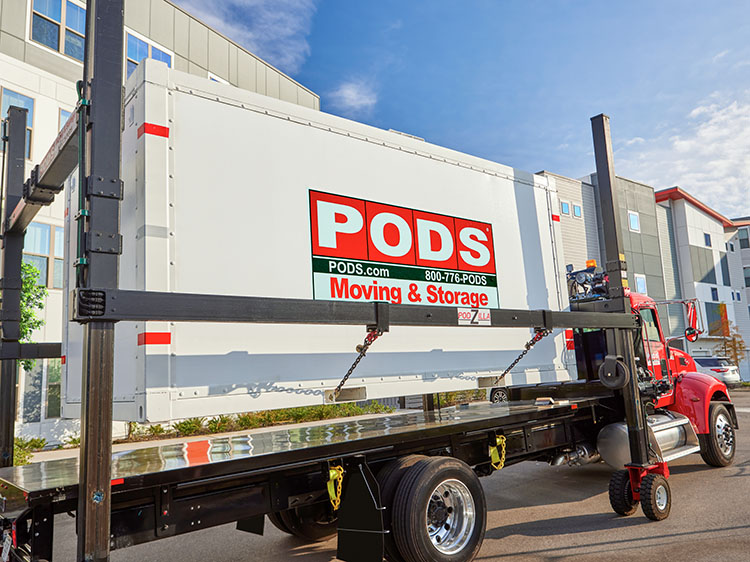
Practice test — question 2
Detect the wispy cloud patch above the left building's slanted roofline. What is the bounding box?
[175,0,316,74]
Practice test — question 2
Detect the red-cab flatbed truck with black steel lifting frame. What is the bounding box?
[0,0,737,562]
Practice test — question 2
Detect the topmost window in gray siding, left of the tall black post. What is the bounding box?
[31,0,86,62]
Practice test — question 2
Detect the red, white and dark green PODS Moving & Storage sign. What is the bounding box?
[310,191,497,306]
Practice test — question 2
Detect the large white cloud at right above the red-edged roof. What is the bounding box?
[616,91,750,218]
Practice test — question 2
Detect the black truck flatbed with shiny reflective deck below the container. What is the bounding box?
[0,388,619,560]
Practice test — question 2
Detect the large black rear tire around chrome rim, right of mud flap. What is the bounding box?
[393,457,487,562]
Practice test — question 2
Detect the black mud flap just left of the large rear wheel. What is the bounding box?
[336,457,385,562]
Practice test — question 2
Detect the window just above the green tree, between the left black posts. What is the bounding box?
[23,222,65,289]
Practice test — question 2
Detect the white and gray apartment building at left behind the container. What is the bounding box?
[0,0,320,443]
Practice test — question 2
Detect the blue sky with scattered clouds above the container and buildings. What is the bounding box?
[178,0,750,217]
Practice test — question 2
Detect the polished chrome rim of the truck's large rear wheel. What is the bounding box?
[425,479,476,555]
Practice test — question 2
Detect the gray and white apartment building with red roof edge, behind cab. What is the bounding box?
[541,168,750,380]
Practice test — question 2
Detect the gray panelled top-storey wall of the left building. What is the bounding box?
[0,0,320,109]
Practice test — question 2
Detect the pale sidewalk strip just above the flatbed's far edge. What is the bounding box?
[31,410,419,463]
